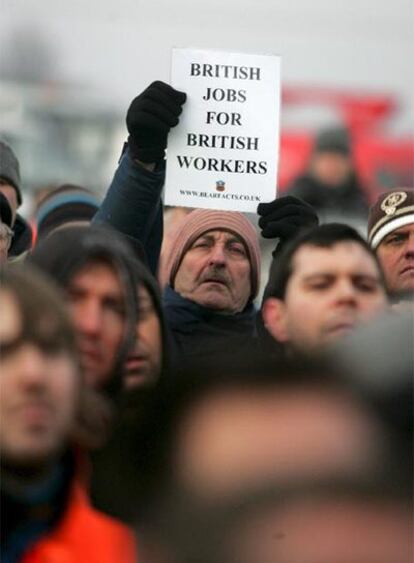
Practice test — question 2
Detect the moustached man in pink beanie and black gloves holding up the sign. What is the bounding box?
[94,53,317,368]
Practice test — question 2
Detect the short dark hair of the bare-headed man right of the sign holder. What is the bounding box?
[265,223,385,299]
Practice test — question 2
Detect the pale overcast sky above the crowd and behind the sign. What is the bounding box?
[0,0,414,121]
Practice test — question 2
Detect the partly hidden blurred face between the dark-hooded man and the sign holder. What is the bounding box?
[124,286,162,389]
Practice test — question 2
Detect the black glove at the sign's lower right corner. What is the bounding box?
[257,195,319,244]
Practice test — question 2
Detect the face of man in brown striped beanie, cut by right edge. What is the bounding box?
[377,224,414,293]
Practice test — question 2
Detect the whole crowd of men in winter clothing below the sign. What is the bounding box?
[0,82,414,563]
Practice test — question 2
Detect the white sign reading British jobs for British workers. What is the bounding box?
[165,49,280,212]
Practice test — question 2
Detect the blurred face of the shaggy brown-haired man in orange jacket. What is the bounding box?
[0,291,79,468]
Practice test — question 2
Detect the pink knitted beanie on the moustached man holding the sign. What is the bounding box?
[160,209,260,299]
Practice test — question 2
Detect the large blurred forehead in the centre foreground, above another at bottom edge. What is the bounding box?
[174,389,379,498]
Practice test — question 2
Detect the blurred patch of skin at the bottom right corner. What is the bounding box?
[231,495,413,563]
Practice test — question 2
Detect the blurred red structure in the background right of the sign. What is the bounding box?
[279,87,414,201]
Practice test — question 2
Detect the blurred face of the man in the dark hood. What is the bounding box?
[67,262,125,388]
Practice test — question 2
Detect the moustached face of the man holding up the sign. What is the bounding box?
[174,230,251,313]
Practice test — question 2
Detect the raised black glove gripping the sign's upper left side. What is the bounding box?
[126,81,187,163]
